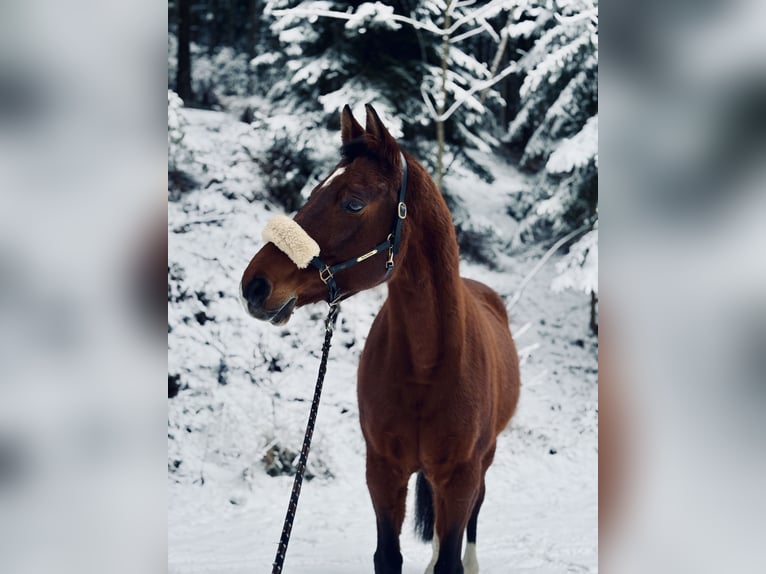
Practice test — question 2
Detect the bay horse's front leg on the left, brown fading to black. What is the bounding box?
[367,445,409,574]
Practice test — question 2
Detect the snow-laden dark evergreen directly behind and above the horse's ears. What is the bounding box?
[253,0,508,184]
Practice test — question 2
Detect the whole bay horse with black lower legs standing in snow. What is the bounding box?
[240,105,520,574]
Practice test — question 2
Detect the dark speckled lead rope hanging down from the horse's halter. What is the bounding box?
[271,304,340,574]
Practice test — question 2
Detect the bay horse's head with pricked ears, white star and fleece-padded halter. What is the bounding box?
[240,105,406,325]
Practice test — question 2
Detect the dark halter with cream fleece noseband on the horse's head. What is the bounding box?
[263,152,407,305]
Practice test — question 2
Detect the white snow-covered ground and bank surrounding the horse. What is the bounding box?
[168,110,598,574]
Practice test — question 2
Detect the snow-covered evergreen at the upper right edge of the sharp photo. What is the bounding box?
[506,0,598,245]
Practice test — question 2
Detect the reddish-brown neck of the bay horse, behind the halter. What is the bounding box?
[388,160,465,372]
